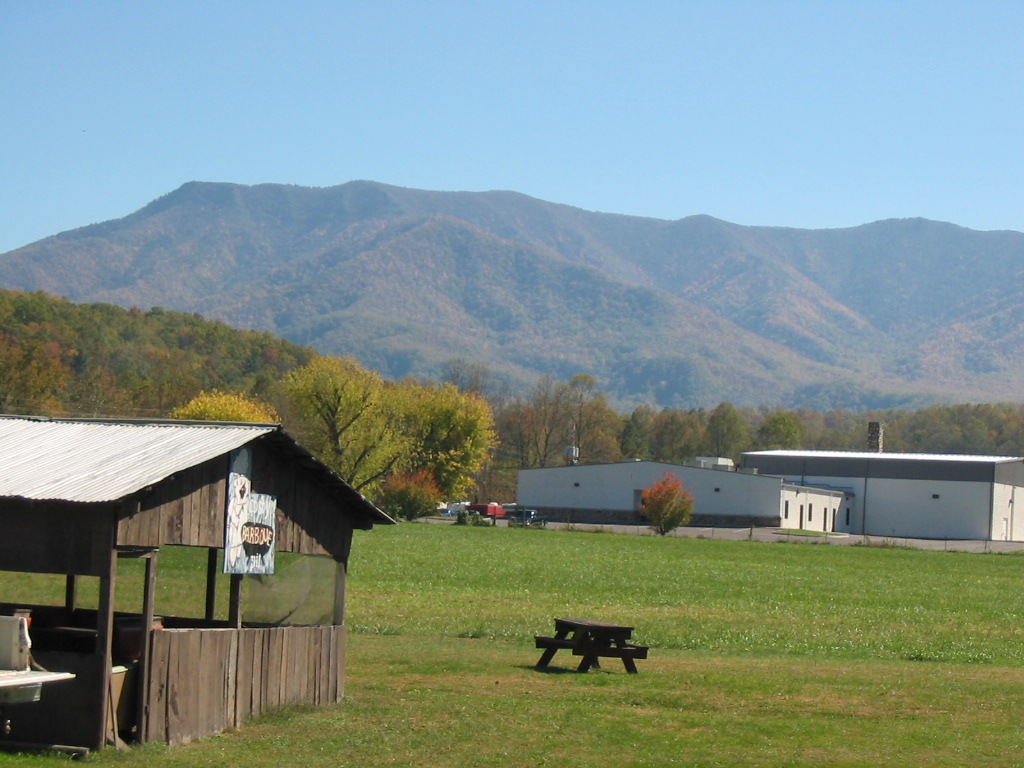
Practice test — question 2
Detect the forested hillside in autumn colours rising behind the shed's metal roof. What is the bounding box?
[0,291,315,417]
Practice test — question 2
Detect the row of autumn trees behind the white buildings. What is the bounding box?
[466,364,1024,498]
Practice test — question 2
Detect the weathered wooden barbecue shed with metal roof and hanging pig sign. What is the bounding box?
[0,416,393,749]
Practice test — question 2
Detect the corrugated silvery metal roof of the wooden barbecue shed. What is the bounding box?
[0,417,279,502]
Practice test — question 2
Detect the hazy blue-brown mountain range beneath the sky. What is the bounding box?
[0,181,1024,409]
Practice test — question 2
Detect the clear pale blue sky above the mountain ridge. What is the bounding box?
[0,0,1024,252]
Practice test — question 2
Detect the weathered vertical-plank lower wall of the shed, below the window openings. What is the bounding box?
[143,626,345,744]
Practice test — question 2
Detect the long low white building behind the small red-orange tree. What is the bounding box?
[518,459,844,530]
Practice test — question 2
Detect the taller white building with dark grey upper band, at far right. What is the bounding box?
[743,451,1024,541]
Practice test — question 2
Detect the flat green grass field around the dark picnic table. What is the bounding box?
[0,524,1024,768]
